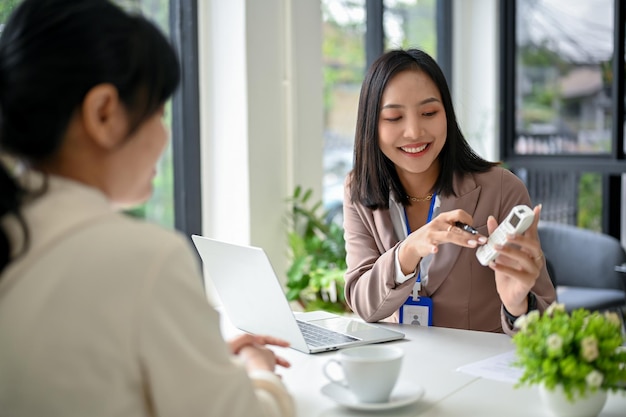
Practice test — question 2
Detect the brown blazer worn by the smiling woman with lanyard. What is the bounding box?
[343,167,556,334]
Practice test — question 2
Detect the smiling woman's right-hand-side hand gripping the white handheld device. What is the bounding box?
[487,205,545,316]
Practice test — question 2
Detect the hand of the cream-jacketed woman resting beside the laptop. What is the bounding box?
[228,334,291,372]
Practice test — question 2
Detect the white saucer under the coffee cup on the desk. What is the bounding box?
[322,381,424,410]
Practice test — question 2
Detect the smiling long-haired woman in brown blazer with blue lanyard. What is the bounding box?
[343,49,555,334]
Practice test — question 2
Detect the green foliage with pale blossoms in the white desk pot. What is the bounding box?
[513,303,626,402]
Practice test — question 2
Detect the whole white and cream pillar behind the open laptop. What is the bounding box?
[198,0,323,286]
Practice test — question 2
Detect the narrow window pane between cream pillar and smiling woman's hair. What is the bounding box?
[321,0,366,209]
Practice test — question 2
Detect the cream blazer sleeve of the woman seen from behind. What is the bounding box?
[136,239,294,417]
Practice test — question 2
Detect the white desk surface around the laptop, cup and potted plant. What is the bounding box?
[224,314,626,417]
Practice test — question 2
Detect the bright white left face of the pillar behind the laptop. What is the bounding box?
[198,0,250,247]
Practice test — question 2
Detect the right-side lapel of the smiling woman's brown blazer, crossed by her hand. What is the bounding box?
[425,175,481,295]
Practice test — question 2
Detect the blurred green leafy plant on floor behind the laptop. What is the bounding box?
[287,186,349,313]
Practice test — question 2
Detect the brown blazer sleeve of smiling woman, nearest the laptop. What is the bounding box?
[343,177,415,322]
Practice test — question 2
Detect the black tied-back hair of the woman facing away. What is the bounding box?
[0,0,180,271]
